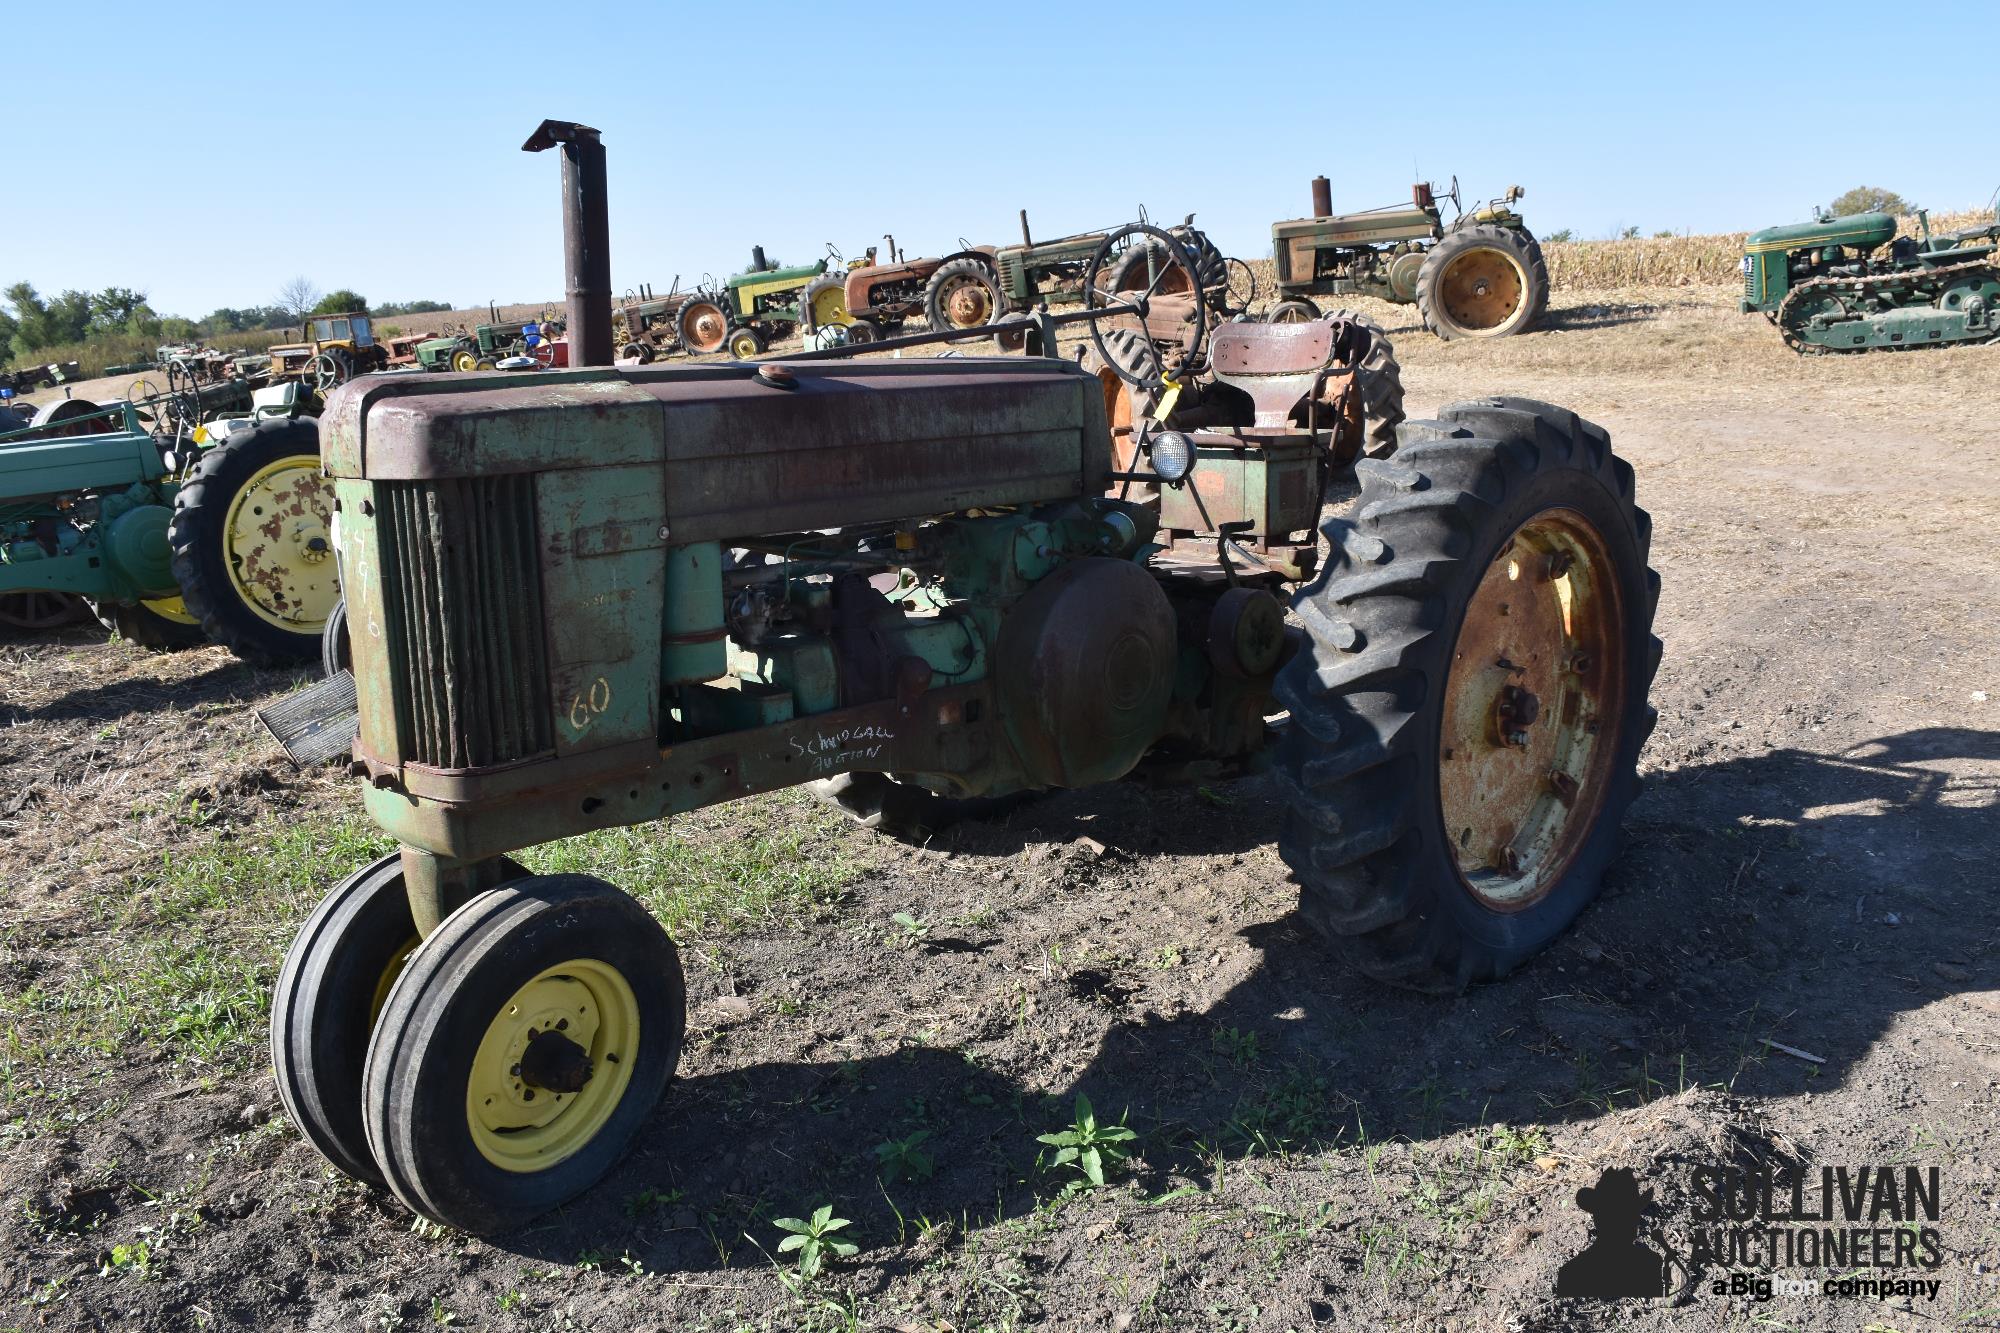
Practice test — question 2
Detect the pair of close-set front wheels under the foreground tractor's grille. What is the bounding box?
[272,853,686,1233]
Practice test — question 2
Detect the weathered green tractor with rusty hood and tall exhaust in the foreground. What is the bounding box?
[272,122,1658,1233]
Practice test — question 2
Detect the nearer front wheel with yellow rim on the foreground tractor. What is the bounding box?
[362,875,686,1235]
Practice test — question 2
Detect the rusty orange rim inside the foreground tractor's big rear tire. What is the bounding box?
[1438,508,1626,913]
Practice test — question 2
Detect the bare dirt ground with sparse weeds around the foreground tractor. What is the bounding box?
[0,288,2000,1333]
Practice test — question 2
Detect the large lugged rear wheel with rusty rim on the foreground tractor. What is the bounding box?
[1276,398,1660,991]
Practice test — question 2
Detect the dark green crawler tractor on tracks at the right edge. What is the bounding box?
[1738,201,2000,354]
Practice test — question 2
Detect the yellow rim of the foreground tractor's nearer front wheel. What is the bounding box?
[466,959,638,1171]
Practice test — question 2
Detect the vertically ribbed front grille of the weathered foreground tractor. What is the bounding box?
[376,474,556,769]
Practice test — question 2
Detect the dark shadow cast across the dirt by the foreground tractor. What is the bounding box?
[502,727,2000,1283]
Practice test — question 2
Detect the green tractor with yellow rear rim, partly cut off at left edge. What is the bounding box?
[0,382,340,662]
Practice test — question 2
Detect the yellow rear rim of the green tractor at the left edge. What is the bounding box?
[222,454,340,634]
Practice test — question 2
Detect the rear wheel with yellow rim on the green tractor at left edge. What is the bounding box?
[168,418,340,664]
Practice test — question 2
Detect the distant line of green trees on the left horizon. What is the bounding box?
[0,278,452,366]
